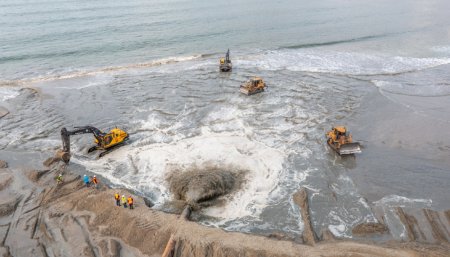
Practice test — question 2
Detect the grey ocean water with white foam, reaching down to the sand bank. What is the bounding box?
[0,0,450,237]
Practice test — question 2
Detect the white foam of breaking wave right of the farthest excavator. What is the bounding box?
[236,49,450,75]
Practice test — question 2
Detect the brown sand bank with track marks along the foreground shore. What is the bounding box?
[0,158,450,257]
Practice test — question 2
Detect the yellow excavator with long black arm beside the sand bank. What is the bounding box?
[56,126,128,163]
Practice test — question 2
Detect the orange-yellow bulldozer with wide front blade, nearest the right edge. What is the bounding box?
[326,126,361,155]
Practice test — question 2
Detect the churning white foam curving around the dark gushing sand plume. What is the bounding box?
[74,129,286,220]
